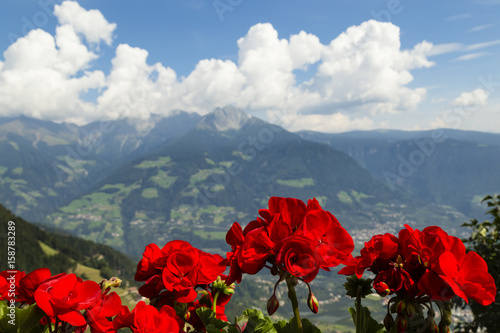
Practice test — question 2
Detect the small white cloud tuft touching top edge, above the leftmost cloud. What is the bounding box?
[54,1,116,45]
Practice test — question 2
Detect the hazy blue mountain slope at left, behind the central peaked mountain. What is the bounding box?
[0,111,200,221]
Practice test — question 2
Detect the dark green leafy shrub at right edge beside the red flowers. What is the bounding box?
[460,194,500,333]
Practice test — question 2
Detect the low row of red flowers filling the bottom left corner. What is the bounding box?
[0,268,179,333]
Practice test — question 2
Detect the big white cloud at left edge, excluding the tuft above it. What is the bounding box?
[0,27,104,121]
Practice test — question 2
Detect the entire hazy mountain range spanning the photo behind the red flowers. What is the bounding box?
[0,106,500,255]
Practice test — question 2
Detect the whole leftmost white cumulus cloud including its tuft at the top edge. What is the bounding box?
[0,1,114,123]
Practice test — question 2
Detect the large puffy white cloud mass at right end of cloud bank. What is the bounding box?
[311,20,433,114]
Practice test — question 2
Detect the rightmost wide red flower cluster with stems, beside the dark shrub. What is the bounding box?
[339,225,497,332]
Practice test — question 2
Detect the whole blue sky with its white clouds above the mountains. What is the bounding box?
[0,0,500,132]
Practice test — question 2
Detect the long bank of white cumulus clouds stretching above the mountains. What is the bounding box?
[0,1,436,131]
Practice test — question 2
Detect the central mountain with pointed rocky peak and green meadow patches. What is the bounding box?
[46,108,463,254]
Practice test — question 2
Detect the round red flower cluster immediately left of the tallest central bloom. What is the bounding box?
[135,240,233,330]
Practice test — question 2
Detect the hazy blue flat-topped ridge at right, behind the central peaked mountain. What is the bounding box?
[299,129,500,216]
